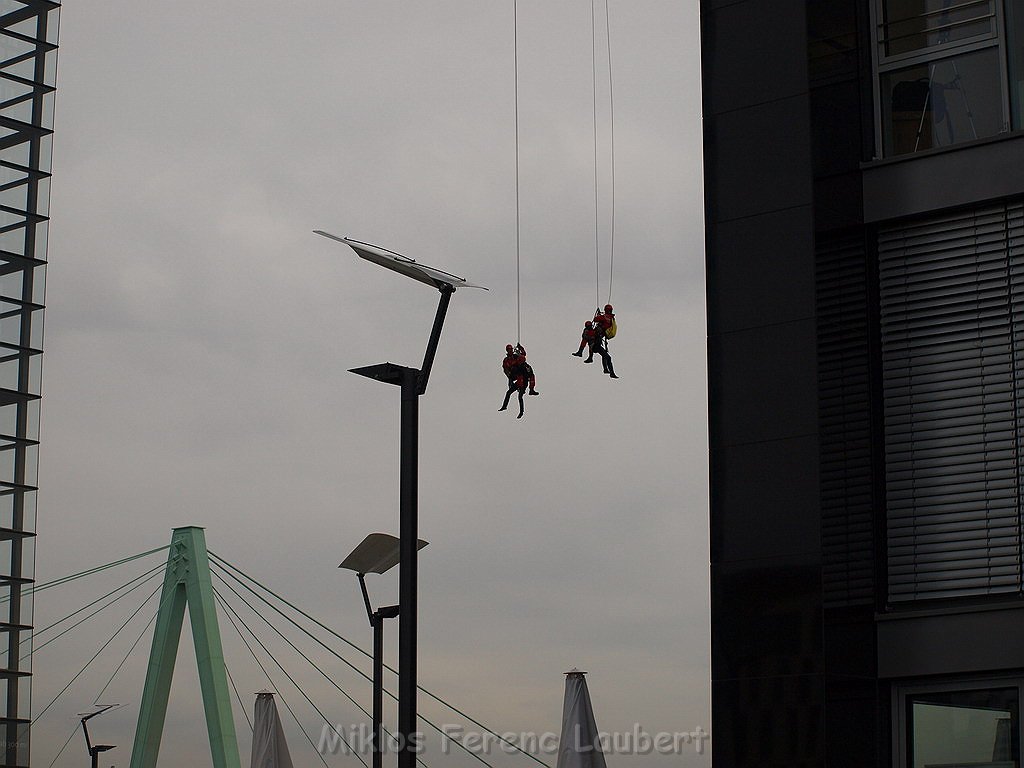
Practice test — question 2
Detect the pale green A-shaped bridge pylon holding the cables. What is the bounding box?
[131,525,241,768]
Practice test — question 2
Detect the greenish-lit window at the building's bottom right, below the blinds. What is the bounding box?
[906,688,1020,768]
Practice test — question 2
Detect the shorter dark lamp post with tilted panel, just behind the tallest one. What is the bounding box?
[338,534,427,768]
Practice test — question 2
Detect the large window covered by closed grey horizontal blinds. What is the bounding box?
[879,202,1024,602]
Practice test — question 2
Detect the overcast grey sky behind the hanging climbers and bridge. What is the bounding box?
[34,0,710,768]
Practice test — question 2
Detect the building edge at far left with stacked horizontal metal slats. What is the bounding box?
[0,0,59,766]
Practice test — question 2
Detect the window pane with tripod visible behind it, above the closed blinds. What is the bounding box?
[881,48,1004,157]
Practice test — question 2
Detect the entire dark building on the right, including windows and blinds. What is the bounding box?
[701,0,1024,768]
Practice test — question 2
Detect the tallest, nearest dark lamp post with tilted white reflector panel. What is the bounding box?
[314,229,486,768]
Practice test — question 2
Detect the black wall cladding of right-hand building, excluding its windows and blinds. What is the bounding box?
[700,0,1024,768]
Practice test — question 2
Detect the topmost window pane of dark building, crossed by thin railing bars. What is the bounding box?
[883,0,995,56]
